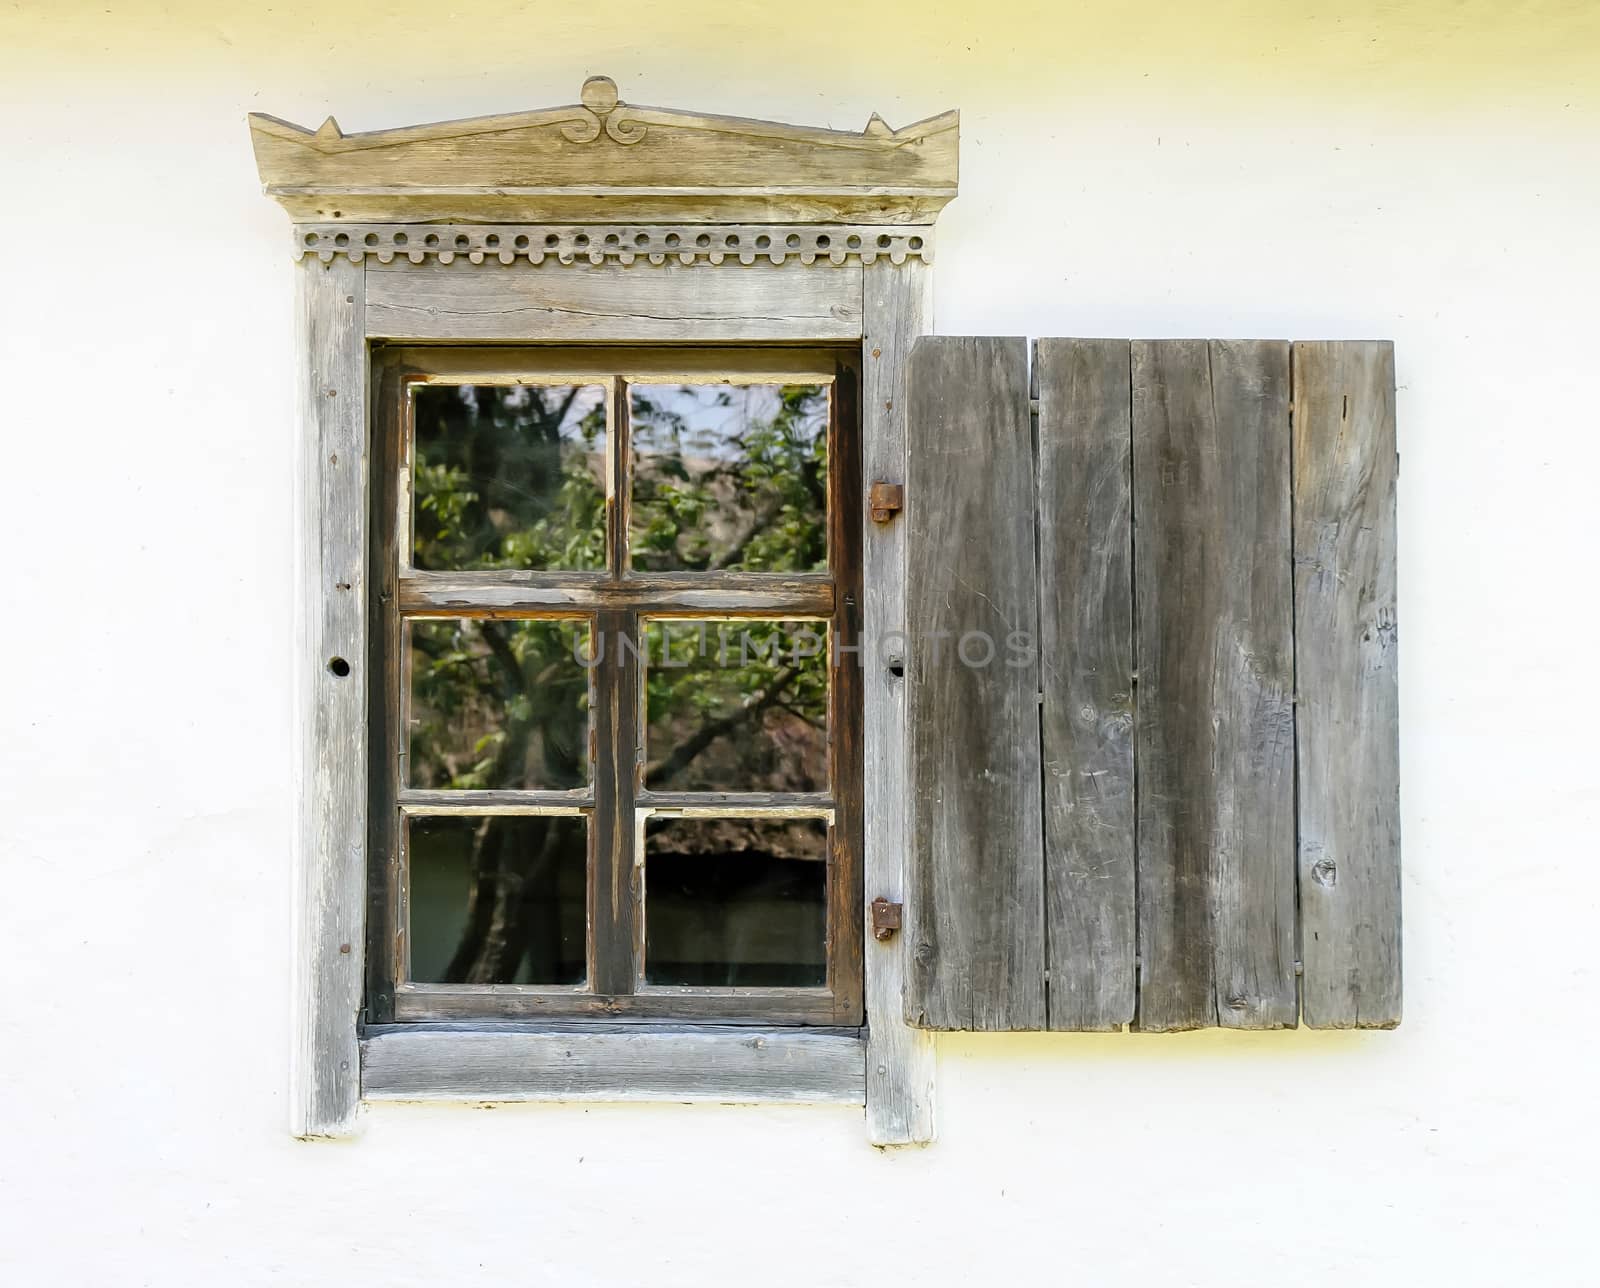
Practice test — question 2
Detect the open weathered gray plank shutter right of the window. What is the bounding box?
[906,338,1400,1032]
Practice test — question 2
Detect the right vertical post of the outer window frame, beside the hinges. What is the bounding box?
[861,259,934,1146]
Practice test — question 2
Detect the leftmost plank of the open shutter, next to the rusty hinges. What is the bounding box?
[906,336,1045,1030]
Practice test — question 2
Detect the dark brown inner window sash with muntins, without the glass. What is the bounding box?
[365,346,862,1027]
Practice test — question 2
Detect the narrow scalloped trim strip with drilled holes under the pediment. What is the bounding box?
[294,224,933,264]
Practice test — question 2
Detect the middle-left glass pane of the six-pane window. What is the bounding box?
[406,618,590,790]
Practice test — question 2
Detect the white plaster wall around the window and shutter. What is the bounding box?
[0,0,1600,1288]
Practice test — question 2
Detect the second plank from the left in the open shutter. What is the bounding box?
[1034,339,1138,1030]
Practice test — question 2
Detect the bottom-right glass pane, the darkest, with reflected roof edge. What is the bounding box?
[645,818,827,987]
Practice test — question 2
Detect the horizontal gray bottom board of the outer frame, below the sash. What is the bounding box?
[362,1026,866,1104]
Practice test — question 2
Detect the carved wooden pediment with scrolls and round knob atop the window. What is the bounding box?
[250,77,960,224]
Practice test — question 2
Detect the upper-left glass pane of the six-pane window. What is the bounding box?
[411,384,606,570]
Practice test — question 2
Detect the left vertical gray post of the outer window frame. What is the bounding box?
[290,258,368,1136]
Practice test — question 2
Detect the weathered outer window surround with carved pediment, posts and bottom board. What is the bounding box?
[264,77,958,1146]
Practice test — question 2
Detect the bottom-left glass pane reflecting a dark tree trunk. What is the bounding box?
[406,814,589,984]
